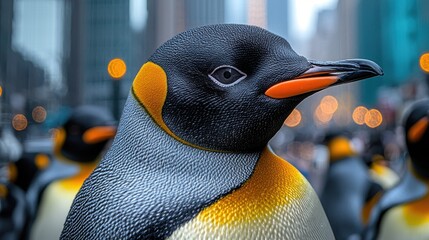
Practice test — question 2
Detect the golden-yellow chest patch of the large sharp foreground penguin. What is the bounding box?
[198,148,306,225]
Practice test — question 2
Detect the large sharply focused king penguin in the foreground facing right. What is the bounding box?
[61,24,381,239]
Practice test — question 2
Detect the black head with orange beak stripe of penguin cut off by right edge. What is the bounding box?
[403,99,429,178]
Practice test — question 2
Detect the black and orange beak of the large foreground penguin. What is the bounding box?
[265,59,383,99]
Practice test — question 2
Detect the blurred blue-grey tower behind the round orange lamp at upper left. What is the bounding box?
[63,0,136,117]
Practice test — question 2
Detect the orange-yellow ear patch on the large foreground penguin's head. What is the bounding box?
[132,62,214,151]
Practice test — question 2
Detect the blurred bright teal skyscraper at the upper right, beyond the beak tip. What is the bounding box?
[357,0,429,103]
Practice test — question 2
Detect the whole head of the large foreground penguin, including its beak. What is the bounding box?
[132,24,382,151]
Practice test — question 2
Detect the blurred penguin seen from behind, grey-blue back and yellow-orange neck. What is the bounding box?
[320,132,371,239]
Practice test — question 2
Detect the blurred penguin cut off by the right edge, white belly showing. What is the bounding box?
[365,99,429,240]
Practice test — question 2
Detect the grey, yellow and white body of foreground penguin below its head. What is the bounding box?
[63,97,330,239]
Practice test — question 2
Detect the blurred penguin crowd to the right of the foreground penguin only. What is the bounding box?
[270,99,429,240]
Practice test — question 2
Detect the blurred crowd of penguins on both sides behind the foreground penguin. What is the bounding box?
[0,96,429,240]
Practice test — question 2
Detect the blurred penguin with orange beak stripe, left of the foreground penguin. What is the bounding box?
[28,106,116,239]
